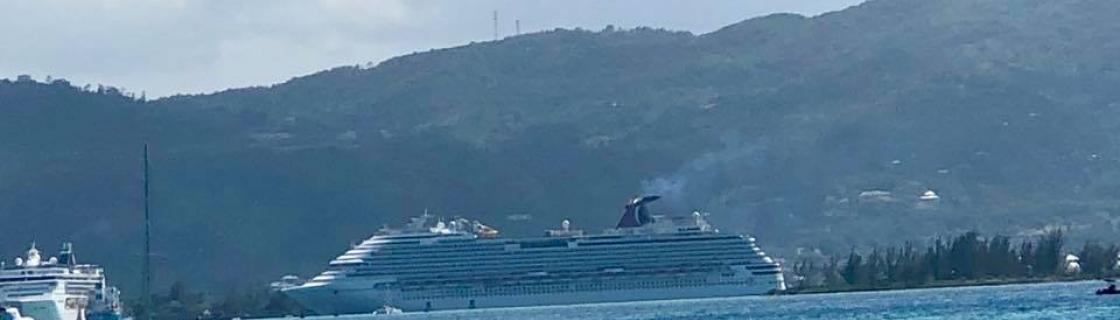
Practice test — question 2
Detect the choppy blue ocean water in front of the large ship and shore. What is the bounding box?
[264,281,1120,320]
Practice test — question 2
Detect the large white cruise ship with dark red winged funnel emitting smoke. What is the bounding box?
[280,196,785,314]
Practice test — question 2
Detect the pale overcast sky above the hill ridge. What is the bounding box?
[0,0,861,97]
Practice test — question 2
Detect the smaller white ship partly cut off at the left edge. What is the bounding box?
[0,243,121,320]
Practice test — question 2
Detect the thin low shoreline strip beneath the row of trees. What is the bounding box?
[782,277,1100,295]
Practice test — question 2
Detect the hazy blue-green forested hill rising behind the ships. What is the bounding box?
[0,0,1120,292]
